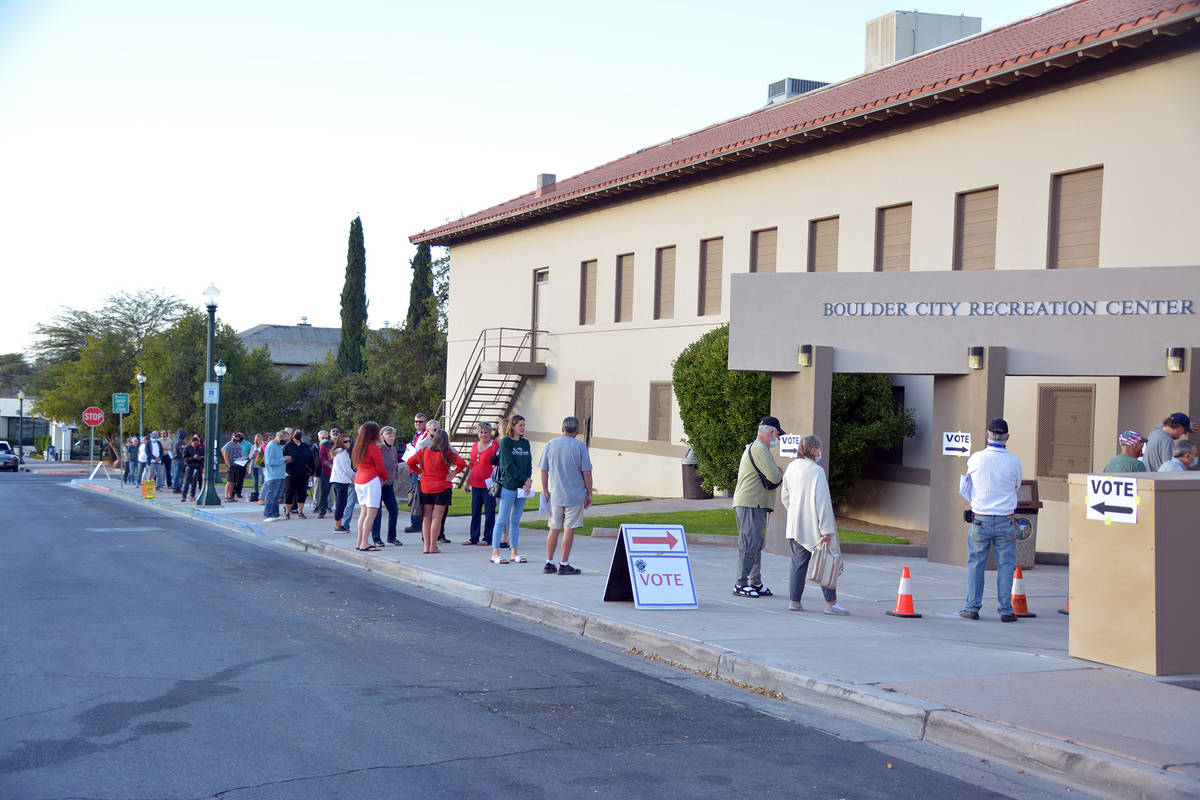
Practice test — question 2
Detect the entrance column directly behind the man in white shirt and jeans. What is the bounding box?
[929,347,1003,566]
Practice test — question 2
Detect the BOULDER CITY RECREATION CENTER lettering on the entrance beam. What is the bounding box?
[823,300,1196,317]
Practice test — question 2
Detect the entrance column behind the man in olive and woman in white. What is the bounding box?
[766,347,833,555]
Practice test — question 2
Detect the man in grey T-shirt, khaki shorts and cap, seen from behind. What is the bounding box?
[538,416,592,575]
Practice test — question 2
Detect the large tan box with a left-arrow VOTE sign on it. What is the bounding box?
[1068,473,1200,675]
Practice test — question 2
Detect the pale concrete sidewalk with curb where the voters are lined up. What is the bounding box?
[72,480,1200,798]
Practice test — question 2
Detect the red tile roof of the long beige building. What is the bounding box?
[409,0,1200,245]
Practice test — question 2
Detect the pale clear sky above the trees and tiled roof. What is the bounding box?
[0,0,1056,353]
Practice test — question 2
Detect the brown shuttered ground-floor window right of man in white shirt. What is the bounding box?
[1038,385,1096,479]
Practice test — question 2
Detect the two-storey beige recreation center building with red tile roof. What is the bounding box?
[412,0,1200,560]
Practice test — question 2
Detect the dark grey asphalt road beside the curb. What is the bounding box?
[0,475,1079,800]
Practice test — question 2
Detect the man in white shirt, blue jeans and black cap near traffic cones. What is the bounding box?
[959,419,1021,622]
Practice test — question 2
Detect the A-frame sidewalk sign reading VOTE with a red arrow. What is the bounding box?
[604,525,700,608]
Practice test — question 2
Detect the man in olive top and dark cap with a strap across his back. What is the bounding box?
[733,416,785,597]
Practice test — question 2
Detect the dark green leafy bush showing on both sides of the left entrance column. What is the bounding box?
[673,325,917,503]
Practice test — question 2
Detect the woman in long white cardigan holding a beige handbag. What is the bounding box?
[780,435,850,615]
